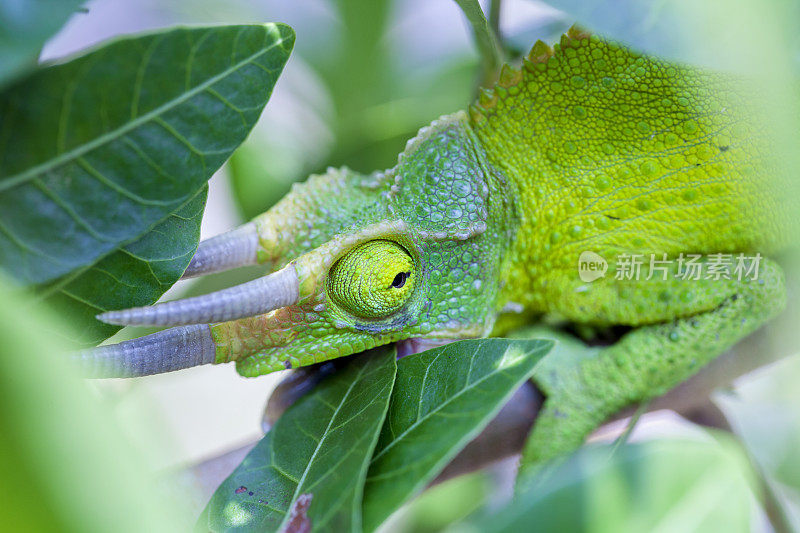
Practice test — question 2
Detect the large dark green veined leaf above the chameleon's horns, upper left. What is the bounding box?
[0,24,294,283]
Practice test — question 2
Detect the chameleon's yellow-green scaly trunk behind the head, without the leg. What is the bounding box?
[470,35,782,311]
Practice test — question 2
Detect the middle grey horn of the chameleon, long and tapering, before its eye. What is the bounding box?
[97,264,299,326]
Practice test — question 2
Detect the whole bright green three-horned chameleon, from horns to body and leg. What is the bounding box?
[79,28,796,461]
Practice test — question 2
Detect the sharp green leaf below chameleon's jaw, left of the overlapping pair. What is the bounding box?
[198,347,396,531]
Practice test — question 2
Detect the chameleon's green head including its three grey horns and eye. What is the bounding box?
[80,113,513,376]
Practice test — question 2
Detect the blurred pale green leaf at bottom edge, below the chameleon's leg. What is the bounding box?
[448,435,753,533]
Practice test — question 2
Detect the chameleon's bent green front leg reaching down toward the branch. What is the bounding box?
[521,260,786,470]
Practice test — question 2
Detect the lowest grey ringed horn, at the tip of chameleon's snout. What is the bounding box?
[73,324,216,378]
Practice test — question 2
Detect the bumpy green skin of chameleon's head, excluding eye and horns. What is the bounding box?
[212,113,512,376]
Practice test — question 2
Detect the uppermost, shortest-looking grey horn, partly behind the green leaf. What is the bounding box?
[181,222,258,279]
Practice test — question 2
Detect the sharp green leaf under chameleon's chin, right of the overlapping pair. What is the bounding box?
[364,339,553,531]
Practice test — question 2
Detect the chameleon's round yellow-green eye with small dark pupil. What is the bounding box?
[328,240,416,318]
